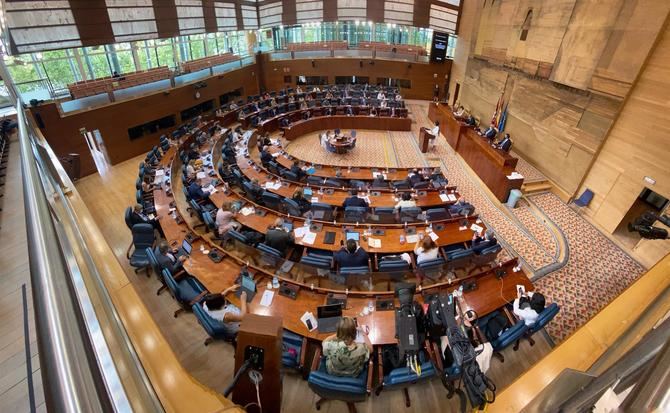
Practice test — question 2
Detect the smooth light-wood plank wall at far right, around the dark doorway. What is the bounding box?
[581,19,670,266]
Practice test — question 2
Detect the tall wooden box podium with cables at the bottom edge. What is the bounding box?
[233,314,283,413]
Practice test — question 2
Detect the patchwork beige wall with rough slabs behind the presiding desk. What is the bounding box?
[452,0,670,194]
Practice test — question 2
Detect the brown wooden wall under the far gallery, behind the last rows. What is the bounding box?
[260,55,451,99]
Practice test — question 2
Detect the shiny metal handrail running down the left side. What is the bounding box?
[17,102,111,412]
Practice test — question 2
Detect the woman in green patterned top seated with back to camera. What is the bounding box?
[322,317,373,377]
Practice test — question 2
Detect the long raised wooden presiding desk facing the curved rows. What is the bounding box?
[428,103,523,202]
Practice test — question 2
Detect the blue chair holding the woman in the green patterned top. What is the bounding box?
[307,347,373,413]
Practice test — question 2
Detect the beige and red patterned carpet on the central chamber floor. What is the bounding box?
[286,101,644,342]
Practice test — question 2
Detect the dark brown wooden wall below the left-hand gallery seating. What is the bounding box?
[31,65,258,176]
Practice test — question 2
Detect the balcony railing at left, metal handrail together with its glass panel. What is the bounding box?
[17,102,163,412]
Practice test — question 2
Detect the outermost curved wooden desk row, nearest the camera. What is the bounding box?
[153,122,533,345]
